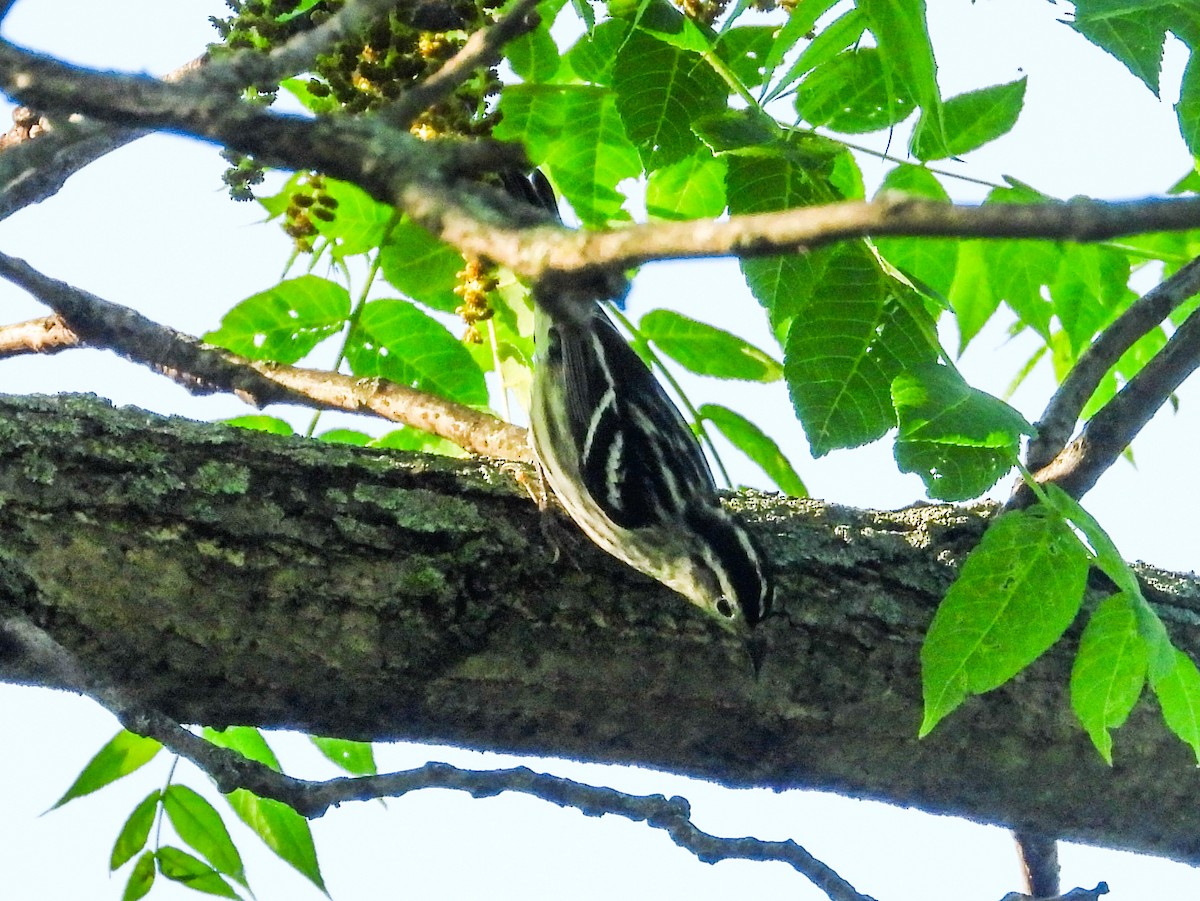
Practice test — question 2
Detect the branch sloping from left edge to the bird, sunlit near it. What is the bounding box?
[0,253,530,461]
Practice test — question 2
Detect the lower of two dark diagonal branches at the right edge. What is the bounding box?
[1008,297,1200,507]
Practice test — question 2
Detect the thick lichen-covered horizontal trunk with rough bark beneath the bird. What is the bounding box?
[0,397,1200,863]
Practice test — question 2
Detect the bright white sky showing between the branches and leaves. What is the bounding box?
[0,0,1200,901]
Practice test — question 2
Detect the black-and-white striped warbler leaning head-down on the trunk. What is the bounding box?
[505,173,773,631]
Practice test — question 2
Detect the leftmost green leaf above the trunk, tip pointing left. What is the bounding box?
[204,275,350,364]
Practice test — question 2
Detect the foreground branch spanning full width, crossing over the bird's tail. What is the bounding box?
[0,42,1200,280]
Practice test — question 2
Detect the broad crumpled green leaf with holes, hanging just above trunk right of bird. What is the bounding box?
[892,365,1034,500]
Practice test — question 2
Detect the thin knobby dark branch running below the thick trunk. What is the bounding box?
[0,615,871,901]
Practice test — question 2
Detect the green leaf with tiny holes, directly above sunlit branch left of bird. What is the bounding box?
[346,300,487,404]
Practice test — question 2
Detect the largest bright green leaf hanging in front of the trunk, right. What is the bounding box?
[920,505,1087,737]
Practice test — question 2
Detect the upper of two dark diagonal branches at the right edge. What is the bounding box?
[1026,258,1200,471]
